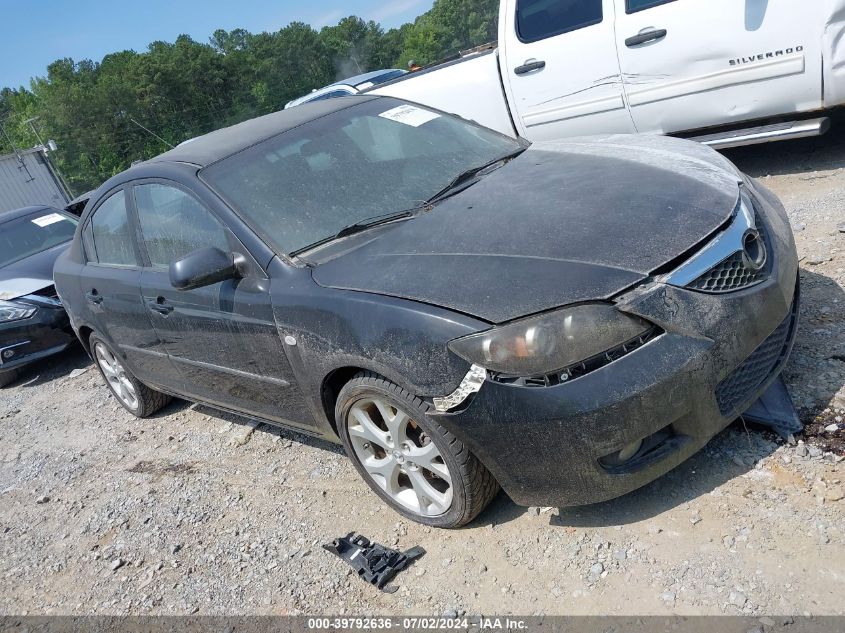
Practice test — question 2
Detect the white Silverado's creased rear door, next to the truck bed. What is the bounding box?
[499,0,634,141]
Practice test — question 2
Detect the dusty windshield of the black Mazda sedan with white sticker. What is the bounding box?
[201,99,525,253]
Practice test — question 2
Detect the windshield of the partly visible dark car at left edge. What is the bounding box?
[0,209,77,268]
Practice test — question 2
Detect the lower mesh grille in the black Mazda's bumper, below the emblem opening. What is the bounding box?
[716,302,797,416]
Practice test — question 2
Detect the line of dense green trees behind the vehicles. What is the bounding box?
[0,0,499,194]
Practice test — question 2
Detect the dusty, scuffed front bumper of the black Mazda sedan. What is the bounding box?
[433,181,798,507]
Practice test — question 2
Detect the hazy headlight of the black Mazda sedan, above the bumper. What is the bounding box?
[449,304,651,376]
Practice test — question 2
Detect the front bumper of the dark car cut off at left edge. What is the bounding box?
[0,304,76,373]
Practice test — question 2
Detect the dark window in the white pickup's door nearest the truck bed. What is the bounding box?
[516,0,600,42]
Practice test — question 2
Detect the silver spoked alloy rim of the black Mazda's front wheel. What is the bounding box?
[346,397,452,517]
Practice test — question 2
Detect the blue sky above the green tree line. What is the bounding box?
[0,0,433,88]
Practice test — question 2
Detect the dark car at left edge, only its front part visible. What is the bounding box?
[0,206,78,387]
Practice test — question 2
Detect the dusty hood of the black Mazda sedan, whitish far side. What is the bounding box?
[312,136,742,323]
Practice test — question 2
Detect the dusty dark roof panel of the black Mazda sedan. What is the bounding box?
[147,95,383,167]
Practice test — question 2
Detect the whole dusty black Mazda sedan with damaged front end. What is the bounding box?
[55,97,798,527]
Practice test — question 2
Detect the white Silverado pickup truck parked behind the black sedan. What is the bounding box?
[372,0,845,147]
